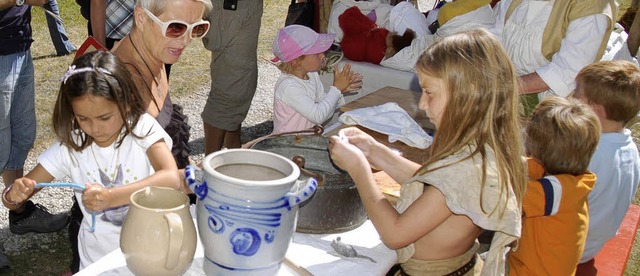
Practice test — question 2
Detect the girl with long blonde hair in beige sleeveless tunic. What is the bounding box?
[329,30,526,275]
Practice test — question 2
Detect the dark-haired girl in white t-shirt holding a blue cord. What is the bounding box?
[2,51,180,269]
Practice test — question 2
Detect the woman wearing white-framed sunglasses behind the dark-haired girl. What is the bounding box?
[113,0,212,168]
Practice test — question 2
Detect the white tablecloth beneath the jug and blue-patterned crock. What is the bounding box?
[75,220,396,276]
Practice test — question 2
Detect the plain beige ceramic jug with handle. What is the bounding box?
[120,187,197,275]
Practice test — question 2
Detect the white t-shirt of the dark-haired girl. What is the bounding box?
[38,113,173,269]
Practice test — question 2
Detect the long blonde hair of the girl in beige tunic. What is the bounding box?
[416,29,526,216]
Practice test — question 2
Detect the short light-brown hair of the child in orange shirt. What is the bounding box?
[525,96,600,175]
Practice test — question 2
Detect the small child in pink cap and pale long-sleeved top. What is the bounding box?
[272,25,362,133]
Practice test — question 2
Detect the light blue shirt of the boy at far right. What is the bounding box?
[580,129,640,263]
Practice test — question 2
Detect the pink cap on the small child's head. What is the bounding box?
[271,25,336,62]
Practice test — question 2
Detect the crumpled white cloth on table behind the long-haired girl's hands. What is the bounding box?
[339,102,433,149]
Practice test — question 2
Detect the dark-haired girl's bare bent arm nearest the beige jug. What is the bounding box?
[82,140,181,211]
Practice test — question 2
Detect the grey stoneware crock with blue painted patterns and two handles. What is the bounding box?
[185,149,317,275]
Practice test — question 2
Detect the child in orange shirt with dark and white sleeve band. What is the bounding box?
[508,96,600,275]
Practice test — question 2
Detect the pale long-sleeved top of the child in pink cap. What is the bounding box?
[273,72,345,133]
